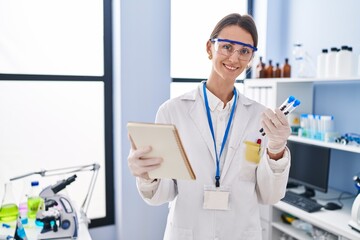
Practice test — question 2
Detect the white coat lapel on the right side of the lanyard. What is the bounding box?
[221,94,251,178]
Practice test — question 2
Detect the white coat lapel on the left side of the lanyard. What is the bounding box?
[189,93,216,163]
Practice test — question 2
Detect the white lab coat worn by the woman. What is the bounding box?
[137,85,290,240]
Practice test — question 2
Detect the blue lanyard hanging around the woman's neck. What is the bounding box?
[203,82,237,187]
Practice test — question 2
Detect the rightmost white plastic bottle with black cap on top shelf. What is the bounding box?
[335,46,354,77]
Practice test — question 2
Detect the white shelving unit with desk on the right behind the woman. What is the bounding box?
[244,77,360,240]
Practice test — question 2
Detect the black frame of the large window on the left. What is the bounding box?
[0,0,115,228]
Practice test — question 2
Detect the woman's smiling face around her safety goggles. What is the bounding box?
[206,25,254,84]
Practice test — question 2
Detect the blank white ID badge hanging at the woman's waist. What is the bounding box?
[203,186,230,210]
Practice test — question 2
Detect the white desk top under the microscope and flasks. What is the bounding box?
[0,218,91,240]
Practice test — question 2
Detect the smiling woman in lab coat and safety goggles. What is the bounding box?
[128,14,290,240]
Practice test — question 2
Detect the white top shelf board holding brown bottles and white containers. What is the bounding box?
[245,76,360,85]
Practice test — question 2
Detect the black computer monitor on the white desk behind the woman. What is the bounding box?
[287,140,330,197]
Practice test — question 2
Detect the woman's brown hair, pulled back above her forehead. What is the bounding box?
[210,13,258,47]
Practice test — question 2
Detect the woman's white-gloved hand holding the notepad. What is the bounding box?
[128,135,163,180]
